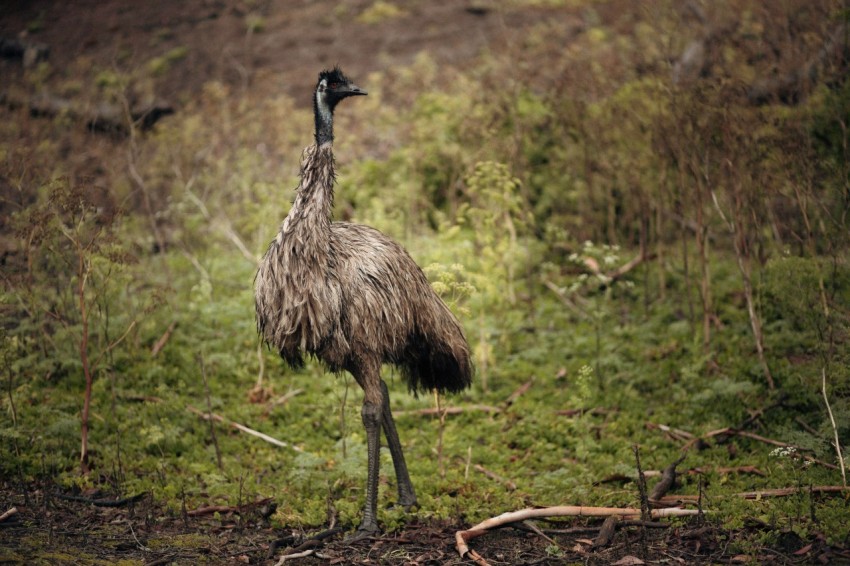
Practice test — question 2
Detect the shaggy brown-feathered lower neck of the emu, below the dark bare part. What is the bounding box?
[278,145,336,263]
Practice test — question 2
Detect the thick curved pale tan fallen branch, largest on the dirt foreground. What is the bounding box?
[455,505,699,565]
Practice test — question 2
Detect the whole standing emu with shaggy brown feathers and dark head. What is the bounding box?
[255,67,473,539]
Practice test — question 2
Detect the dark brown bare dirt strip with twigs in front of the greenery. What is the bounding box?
[0,482,836,566]
